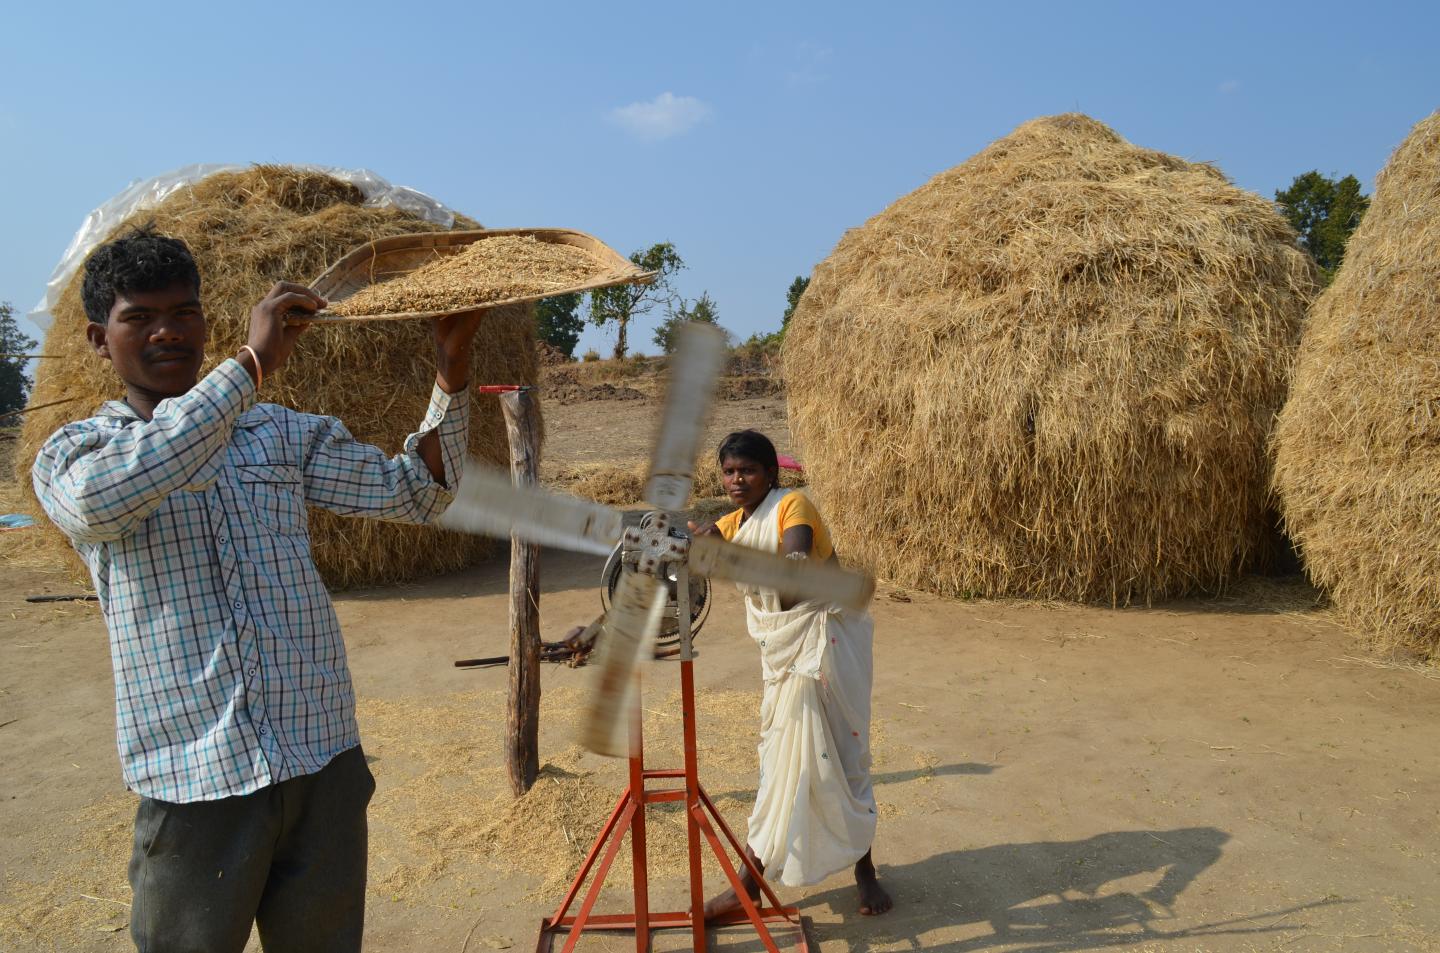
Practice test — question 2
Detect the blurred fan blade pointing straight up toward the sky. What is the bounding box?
[645,324,724,511]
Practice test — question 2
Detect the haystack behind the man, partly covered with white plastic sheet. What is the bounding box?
[16,166,537,587]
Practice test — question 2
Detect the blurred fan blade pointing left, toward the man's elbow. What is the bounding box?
[439,461,624,556]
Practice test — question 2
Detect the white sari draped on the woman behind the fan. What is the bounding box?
[732,488,876,887]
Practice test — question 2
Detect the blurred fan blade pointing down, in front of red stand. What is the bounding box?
[580,570,665,757]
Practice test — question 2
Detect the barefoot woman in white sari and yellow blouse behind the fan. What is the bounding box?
[690,430,891,918]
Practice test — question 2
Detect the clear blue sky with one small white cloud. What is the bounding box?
[0,0,1440,358]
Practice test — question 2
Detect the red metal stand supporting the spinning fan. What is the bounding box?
[536,570,809,953]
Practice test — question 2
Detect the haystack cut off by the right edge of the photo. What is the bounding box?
[1274,112,1440,656]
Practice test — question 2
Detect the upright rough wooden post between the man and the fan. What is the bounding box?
[500,390,540,798]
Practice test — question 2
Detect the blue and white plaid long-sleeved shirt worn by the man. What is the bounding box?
[32,360,469,803]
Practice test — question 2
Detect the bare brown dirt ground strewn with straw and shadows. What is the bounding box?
[0,388,1440,953]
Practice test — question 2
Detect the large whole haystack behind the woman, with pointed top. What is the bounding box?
[783,114,1316,603]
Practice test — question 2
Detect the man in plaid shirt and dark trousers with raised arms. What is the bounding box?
[32,229,480,953]
